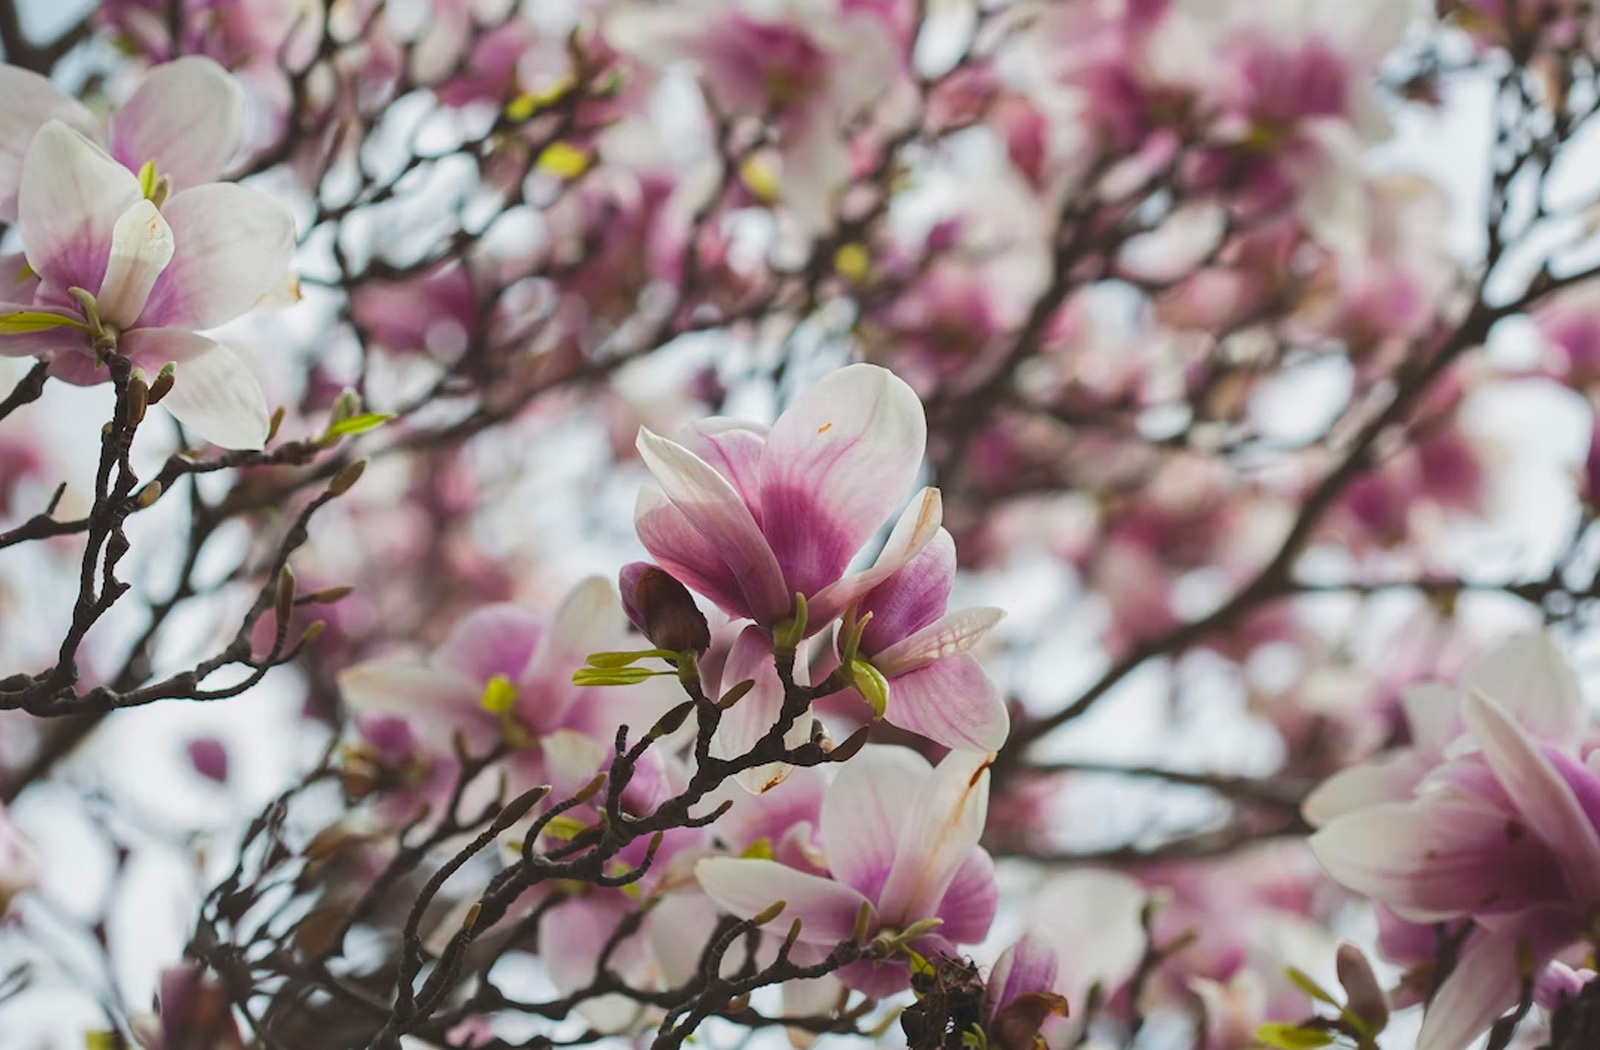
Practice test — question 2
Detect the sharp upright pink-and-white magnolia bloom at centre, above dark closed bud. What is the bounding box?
[635,365,939,634]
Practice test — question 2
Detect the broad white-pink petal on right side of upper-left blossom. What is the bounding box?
[139,182,294,328]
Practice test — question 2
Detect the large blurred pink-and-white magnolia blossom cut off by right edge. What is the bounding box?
[1310,635,1600,1050]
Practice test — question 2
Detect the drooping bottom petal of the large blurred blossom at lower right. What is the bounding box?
[1416,909,1576,1050]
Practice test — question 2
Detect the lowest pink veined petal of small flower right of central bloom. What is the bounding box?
[883,653,1011,751]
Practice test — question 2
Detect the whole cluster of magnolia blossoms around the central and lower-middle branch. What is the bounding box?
[329,365,1011,1031]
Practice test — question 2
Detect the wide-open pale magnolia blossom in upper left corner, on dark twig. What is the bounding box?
[0,59,296,448]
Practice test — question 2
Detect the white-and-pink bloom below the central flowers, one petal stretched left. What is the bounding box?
[694,746,998,997]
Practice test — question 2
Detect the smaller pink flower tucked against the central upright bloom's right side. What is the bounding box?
[842,528,1011,751]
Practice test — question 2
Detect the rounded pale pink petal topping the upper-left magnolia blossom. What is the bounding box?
[110,56,245,190]
